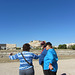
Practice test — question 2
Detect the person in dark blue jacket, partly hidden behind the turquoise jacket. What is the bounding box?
[39,41,47,68]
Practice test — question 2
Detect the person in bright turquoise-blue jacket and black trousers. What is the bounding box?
[44,42,58,75]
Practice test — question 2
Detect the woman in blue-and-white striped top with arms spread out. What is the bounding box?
[9,43,38,75]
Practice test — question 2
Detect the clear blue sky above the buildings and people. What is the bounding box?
[0,0,75,46]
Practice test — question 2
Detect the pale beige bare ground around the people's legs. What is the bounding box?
[0,59,75,75]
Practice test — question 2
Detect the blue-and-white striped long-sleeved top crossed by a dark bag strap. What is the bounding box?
[9,51,39,70]
